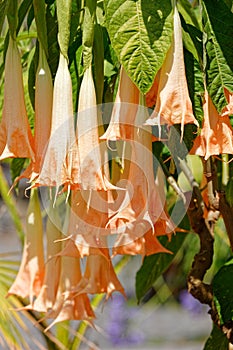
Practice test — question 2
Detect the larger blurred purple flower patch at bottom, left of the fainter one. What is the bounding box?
[107,294,145,346]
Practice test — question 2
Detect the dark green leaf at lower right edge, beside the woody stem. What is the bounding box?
[213,258,233,325]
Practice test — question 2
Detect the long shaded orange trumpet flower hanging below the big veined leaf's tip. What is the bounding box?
[108,99,174,254]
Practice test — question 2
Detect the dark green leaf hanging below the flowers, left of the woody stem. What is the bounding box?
[136,201,189,302]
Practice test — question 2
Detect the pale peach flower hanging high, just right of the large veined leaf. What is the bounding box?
[147,7,197,136]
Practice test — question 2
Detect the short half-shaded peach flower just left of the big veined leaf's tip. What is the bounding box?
[101,66,139,140]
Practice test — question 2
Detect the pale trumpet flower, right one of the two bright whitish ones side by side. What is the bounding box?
[76,66,114,190]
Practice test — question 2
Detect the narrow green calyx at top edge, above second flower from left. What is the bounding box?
[33,0,48,55]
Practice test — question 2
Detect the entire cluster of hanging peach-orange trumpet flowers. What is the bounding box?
[0,8,233,326]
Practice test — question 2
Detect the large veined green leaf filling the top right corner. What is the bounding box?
[202,0,233,112]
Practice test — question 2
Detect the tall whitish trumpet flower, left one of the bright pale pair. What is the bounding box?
[36,54,79,188]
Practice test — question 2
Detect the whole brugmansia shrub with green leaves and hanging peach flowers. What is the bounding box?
[0,0,233,348]
